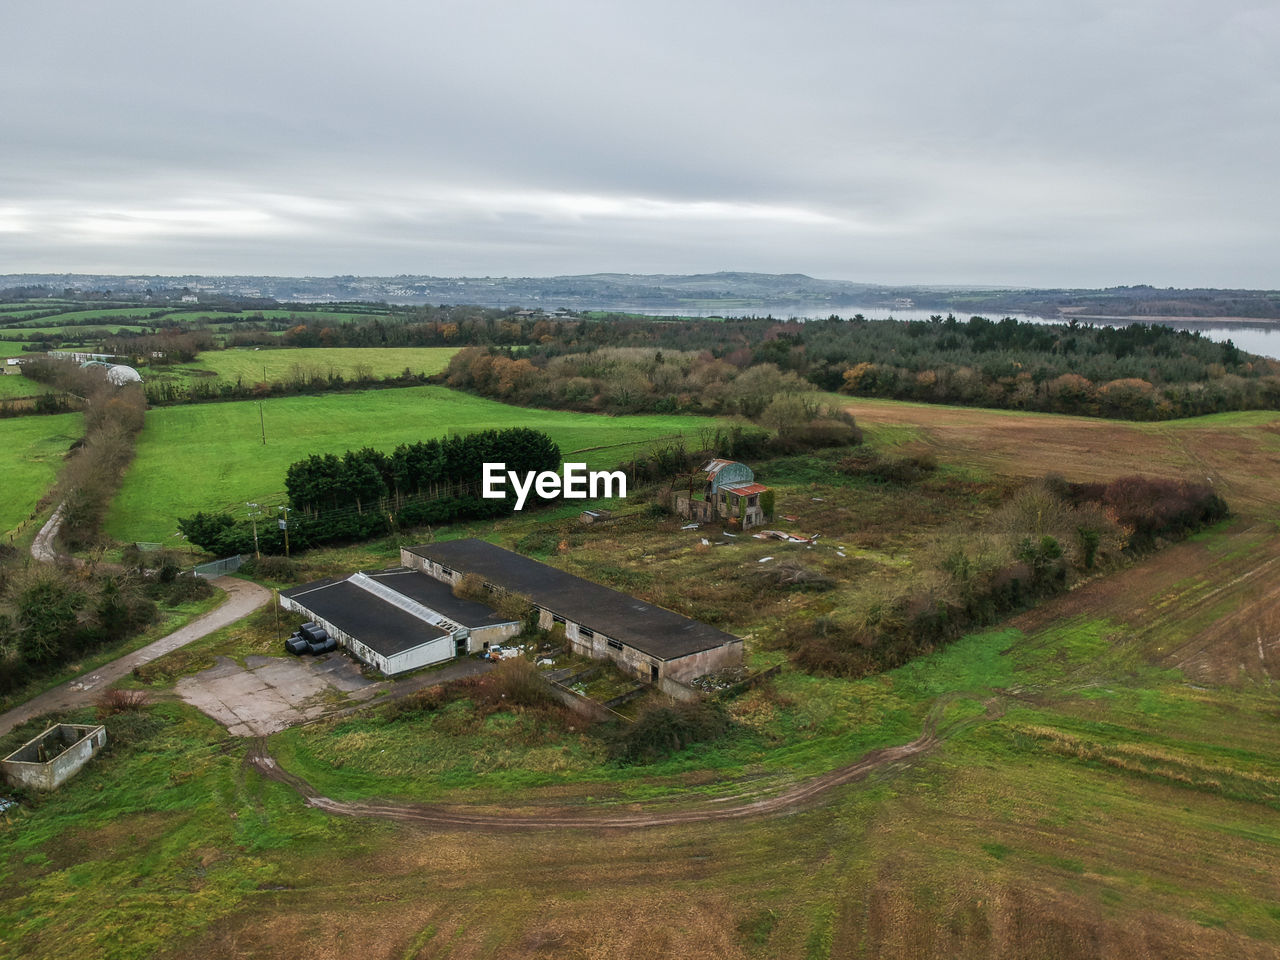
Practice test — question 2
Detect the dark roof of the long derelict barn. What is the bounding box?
[408,540,741,660]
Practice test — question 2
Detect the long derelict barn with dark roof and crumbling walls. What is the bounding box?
[401,540,742,681]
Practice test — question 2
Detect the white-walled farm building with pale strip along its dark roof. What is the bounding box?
[280,570,520,676]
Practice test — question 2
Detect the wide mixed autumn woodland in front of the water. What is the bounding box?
[432,317,1280,420]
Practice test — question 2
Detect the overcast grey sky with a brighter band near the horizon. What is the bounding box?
[0,0,1280,288]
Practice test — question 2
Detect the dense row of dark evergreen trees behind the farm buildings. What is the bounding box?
[178,428,561,556]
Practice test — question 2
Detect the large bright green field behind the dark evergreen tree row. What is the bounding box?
[106,386,713,541]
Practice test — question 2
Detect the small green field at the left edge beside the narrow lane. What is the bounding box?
[0,414,82,532]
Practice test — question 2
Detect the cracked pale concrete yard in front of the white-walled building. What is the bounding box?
[175,652,390,737]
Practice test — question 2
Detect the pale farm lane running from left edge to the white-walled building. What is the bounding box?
[0,577,271,736]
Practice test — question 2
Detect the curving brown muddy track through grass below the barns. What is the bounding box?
[244,691,1004,832]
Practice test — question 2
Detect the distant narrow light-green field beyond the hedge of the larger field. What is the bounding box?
[152,347,457,383]
